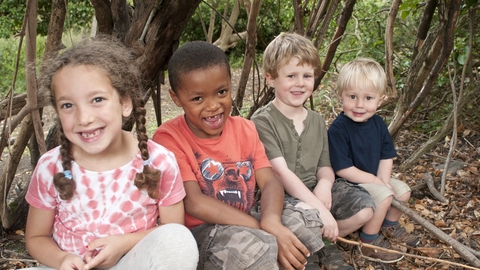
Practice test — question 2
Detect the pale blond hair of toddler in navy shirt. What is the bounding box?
[337,57,387,96]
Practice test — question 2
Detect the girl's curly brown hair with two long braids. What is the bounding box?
[40,37,161,200]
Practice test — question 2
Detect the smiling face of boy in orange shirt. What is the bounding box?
[170,65,232,139]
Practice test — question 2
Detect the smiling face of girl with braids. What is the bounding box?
[52,65,132,157]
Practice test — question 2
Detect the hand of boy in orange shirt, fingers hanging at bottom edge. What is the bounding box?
[273,225,310,270]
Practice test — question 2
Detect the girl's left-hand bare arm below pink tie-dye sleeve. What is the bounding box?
[25,206,84,270]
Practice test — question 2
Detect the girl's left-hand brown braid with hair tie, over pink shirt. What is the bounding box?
[53,124,76,201]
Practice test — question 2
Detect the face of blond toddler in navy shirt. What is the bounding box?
[340,82,384,122]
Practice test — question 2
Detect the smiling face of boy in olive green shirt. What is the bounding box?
[266,57,315,107]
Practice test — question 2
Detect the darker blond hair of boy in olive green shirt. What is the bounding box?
[263,33,322,78]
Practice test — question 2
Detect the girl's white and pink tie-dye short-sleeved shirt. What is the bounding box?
[25,141,185,256]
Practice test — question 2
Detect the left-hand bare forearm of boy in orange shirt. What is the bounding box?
[184,181,260,229]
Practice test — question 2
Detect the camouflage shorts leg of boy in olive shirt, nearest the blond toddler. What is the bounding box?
[330,178,375,220]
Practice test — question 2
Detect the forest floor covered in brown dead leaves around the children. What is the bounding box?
[0,71,480,270]
